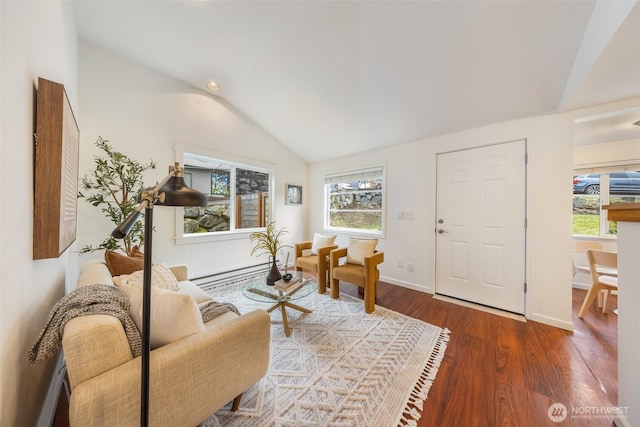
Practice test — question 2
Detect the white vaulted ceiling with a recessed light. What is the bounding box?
[74,0,640,162]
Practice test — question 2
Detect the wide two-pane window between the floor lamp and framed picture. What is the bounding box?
[183,153,272,236]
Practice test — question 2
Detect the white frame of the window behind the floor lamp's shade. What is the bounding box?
[175,144,276,245]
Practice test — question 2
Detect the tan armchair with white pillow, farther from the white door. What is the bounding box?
[294,233,338,294]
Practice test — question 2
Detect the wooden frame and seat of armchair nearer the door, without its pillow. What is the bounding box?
[329,248,384,313]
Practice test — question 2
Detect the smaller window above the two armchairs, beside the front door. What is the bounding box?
[324,165,385,236]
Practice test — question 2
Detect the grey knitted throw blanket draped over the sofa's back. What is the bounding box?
[28,285,142,365]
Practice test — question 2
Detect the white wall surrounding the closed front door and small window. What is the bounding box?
[309,99,640,330]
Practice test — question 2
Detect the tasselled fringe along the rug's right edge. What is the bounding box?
[398,328,451,427]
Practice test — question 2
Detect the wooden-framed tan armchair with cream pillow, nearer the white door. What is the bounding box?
[329,239,384,313]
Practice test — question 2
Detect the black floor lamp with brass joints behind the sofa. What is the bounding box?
[111,163,207,427]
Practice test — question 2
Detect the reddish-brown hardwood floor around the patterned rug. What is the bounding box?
[53,283,618,427]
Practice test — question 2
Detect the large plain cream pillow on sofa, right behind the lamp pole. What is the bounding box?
[118,283,204,348]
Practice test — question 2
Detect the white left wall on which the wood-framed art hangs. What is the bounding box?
[0,2,79,426]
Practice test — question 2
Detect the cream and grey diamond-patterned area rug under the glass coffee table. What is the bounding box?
[202,284,449,427]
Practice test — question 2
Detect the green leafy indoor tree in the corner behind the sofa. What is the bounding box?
[78,136,156,255]
